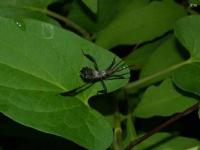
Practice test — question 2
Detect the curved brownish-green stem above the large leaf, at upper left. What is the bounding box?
[21,6,90,40]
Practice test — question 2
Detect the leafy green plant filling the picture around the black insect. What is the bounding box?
[0,0,200,150]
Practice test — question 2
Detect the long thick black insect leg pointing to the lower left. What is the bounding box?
[60,83,94,96]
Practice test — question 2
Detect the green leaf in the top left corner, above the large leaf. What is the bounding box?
[0,0,58,25]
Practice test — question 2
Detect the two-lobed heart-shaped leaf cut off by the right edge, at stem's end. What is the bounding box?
[173,15,200,95]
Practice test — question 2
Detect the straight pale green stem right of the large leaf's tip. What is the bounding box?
[125,59,193,91]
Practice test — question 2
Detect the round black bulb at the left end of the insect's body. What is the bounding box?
[80,67,93,81]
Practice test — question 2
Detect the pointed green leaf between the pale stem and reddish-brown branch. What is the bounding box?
[133,79,197,118]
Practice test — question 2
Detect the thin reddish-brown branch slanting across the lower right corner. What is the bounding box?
[125,102,200,150]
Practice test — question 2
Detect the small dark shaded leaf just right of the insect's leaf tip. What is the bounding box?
[123,34,169,69]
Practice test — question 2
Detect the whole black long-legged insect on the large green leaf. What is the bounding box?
[60,50,129,96]
